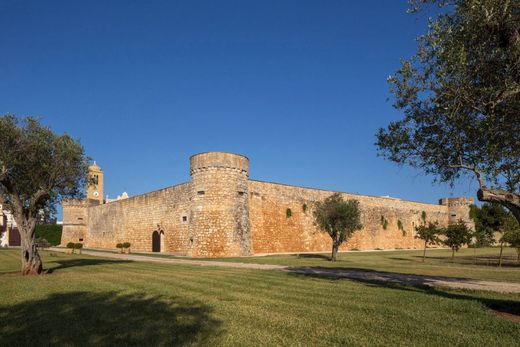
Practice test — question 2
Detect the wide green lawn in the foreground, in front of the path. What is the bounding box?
[0,250,520,346]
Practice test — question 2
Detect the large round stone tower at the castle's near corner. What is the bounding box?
[190,152,251,256]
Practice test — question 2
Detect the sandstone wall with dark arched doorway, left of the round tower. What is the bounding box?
[85,183,193,255]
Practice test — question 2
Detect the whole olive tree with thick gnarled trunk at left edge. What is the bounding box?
[0,114,88,275]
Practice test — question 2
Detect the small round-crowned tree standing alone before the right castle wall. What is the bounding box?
[314,193,363,261]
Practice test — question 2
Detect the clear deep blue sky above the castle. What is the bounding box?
[0,0,477,218]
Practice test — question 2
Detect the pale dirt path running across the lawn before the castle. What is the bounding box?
[49,248,520,293]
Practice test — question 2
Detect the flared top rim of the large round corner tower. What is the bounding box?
[190,152,249,176]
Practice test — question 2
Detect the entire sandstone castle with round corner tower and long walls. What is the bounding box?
[61,152,473,257]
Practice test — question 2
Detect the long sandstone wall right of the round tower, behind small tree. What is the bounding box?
[249,180,449,253]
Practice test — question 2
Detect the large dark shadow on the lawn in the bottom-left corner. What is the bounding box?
[0,292,221,346]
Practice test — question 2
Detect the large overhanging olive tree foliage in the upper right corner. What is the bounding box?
[376,0,520,226]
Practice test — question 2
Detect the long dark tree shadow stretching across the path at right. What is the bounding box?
[287,267,520,321]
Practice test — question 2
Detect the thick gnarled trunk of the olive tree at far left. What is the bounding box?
[19,220,43,276]
